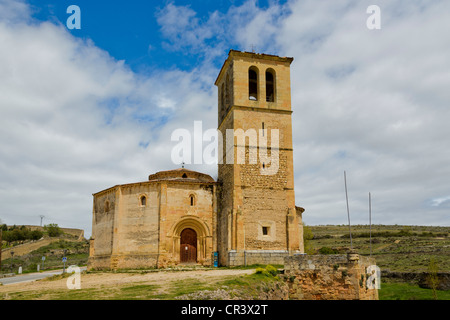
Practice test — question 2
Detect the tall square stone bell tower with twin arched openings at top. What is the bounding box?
[215,50,303,266]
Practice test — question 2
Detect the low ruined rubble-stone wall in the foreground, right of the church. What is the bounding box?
[284,253,378,300]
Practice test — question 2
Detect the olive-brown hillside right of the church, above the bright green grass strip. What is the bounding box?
[308,225,450,272]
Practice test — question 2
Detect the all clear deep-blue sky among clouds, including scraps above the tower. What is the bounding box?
[29,0,285,72]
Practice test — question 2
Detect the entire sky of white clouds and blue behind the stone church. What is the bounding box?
[0,0,450,237]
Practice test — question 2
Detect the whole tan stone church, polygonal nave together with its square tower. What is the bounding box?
[88,50,304,269]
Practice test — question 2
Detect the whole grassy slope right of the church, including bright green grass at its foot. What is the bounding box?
[305,225,450,300]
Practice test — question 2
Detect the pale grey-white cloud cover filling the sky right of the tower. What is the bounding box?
[278,1,450,225]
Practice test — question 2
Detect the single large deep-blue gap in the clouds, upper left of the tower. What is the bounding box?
[27,1,200,71]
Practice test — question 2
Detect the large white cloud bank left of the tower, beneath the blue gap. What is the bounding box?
[0,6,215,235]
